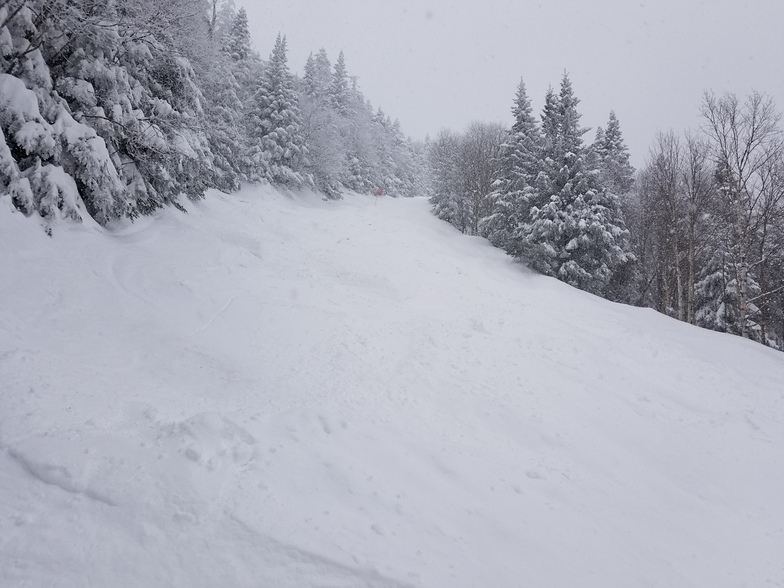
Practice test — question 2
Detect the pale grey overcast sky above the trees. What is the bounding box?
[240,0,784,166]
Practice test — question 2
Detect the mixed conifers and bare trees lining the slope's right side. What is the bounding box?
[428,74,784,349]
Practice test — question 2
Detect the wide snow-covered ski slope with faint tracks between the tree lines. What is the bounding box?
[0,188,784,588]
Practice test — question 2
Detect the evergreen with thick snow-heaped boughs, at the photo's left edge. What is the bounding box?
[0,0,128,230]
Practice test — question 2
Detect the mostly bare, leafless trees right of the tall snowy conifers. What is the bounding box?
[628,92,784,349]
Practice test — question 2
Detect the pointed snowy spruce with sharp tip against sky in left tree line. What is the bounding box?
[249,35,307,187]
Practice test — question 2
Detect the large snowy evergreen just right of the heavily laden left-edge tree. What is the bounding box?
[76,0,212,213]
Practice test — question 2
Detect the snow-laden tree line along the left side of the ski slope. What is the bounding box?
[0,0,424,225]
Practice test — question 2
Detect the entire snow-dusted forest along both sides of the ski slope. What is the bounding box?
[0,0,784,349]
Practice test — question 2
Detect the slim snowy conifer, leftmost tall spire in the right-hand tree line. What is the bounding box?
[482,80,542,257]
